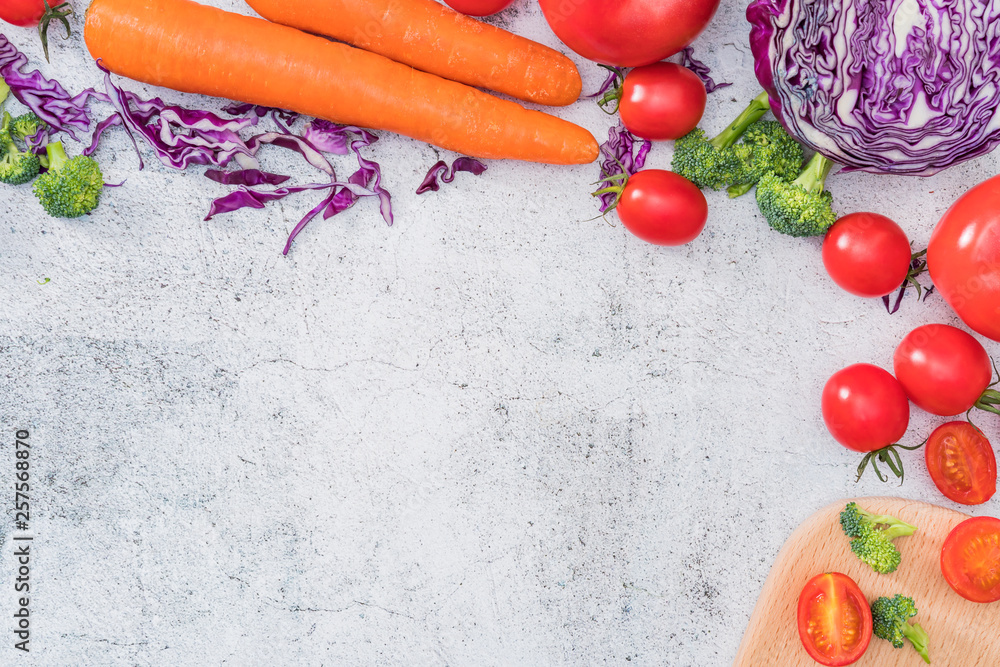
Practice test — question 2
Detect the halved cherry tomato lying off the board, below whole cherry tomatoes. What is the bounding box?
[924,421,997,505]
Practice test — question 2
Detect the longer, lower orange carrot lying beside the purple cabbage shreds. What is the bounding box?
[85,0,598,164]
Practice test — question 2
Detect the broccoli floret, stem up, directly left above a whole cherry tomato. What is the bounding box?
[757,153,837,236]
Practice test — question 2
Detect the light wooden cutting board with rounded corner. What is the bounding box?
[733,498,1000,667]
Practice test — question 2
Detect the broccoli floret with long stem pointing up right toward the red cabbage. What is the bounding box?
[670,93,771,190]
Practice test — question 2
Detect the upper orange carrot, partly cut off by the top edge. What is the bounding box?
[246,0,581,106]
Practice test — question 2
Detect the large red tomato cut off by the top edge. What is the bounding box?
[539,0,719,67]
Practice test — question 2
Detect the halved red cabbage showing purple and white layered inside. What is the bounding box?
[747,0,1000,176]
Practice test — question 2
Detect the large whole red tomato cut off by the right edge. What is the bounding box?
[927,176,1000,341]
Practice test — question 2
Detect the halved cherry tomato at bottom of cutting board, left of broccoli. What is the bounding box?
[798,572,872,667]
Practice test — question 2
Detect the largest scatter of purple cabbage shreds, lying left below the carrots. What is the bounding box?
[0,49,396,254]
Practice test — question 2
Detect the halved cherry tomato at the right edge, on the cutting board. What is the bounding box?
[941,516,1000,602]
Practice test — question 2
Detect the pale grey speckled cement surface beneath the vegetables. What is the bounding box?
[0,0,1000,667]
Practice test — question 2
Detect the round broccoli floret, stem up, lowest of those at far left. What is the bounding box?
[34,141,104,218]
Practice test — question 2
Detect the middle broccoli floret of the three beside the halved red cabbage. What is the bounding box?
[728,120,802,197]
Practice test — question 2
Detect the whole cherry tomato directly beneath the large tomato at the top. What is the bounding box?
[618,63,708,141]
